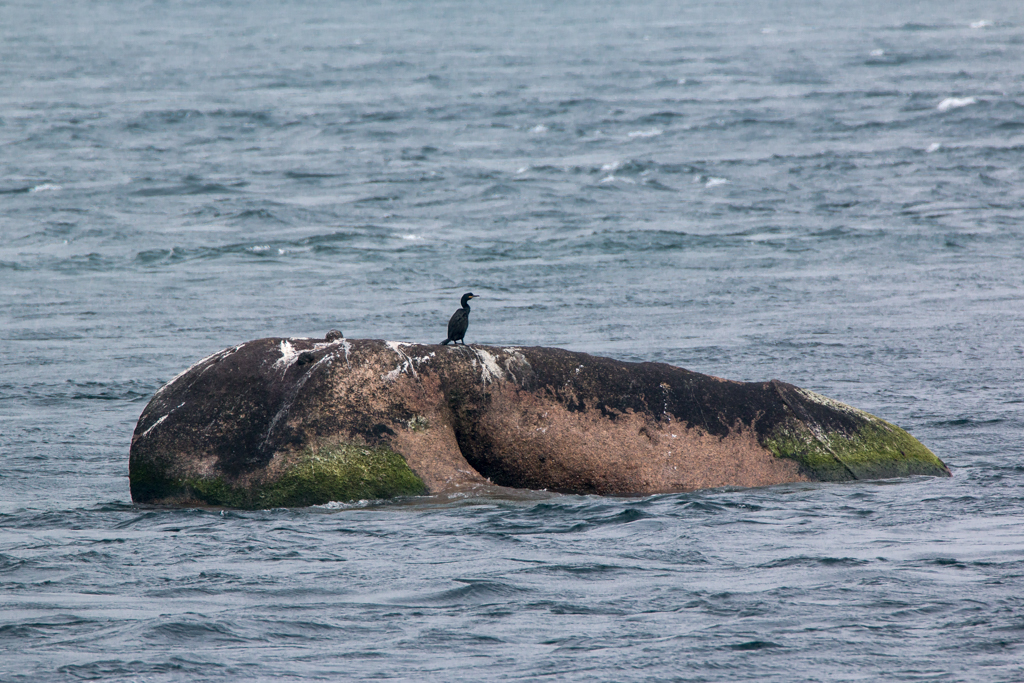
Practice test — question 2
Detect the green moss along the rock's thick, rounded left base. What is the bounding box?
[131,444,426,510]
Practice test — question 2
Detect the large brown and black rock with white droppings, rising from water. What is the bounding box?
[129,339,949,508]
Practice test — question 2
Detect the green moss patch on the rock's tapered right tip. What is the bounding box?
[764,414,949,481]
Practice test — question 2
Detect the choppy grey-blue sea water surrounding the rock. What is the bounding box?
[0,0,1024,681]
